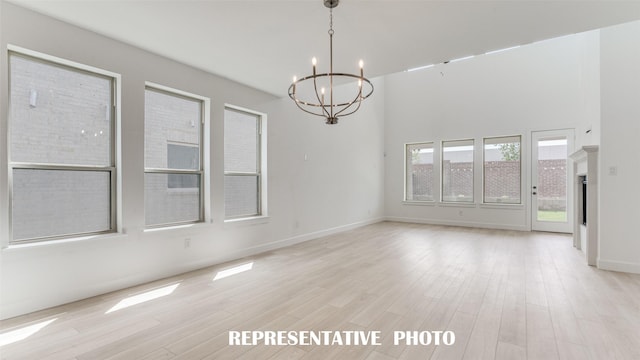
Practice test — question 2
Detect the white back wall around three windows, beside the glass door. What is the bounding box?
[385,32,600,230]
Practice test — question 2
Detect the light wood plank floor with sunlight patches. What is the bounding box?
[0,222,640,360]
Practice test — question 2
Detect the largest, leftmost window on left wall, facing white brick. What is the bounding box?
[9,50,118,243]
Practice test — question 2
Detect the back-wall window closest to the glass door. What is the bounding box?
[484,136,521,204]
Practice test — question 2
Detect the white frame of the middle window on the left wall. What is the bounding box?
[144,81,210,229]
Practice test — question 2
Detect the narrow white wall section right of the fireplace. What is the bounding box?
[598,22,640,273]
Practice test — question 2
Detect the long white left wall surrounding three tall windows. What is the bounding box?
[0,2,384,318]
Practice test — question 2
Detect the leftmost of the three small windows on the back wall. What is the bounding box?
[405,143,434,201]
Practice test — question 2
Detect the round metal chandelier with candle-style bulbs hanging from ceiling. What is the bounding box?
[289,0,373,124]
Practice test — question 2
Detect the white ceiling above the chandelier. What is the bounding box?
[8,0,640,96]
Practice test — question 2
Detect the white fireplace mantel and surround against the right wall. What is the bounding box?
[569,145,600,266]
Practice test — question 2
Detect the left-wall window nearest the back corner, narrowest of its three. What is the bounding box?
[224,107,265,219]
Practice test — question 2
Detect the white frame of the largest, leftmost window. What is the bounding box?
[7,44,121,242]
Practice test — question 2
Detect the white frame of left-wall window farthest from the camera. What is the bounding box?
[223,104,268,222]
